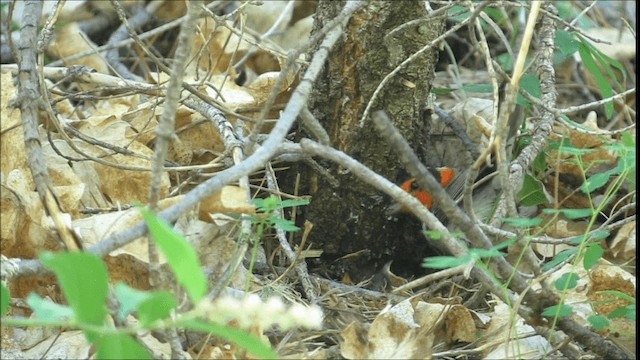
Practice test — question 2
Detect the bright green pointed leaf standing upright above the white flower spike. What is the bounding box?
[140,207,207,303]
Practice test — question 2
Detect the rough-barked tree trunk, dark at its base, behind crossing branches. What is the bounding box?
[301,1,444,280]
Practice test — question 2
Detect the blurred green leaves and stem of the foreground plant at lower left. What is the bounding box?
[1,204,282,359]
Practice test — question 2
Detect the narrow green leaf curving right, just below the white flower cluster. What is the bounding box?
[179,320,278,359]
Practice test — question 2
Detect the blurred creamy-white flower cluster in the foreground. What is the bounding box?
[200,294,323,330]
